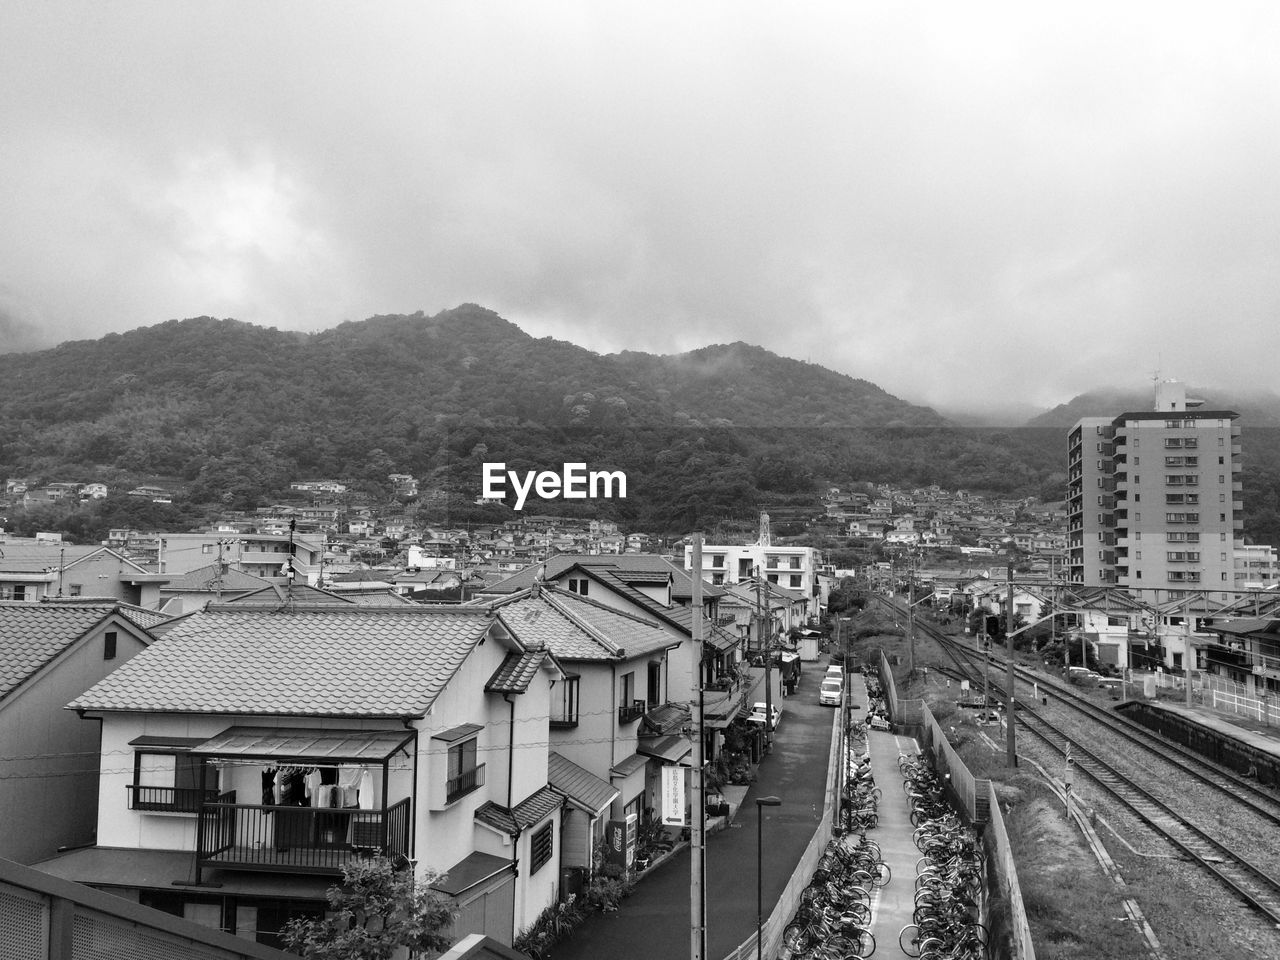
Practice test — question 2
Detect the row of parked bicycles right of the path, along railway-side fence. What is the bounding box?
[897,755,988,960]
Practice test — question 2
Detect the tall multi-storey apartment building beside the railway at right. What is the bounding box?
[1066,380,1244,604]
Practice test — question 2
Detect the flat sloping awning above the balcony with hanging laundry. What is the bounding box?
[191,727,413,763]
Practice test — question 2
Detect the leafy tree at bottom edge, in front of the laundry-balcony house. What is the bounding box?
[280,856,456,960]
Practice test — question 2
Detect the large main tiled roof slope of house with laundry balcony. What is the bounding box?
[70,603,493,717]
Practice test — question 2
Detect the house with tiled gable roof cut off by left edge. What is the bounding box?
[0,600,164,863]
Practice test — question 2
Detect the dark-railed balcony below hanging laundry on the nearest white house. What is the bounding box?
[196,791,410,876]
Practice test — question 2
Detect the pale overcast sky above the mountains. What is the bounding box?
[0,0,1280,419]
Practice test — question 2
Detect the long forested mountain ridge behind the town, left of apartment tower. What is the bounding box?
[0,305,1100,531]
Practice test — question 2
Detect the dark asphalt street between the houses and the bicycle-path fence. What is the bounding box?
[550,663,839,960]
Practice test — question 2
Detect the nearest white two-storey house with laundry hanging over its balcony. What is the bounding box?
[37,598,564,946]
